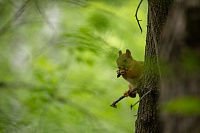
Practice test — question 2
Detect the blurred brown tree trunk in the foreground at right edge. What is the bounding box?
[160,0,200,133]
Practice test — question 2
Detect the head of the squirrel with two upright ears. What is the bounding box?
[117,49,134,70]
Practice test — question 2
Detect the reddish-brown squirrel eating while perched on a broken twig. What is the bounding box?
[116,49,144,98]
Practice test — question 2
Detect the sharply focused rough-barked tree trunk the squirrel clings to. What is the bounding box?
[135,0,173,133]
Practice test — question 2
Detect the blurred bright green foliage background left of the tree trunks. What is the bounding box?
[0,0,147,133]
